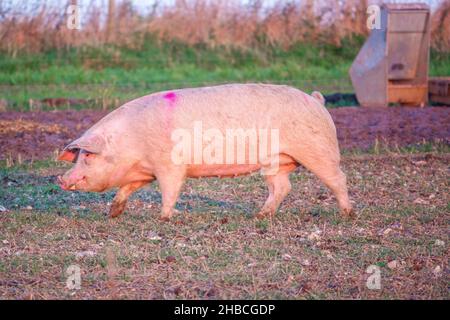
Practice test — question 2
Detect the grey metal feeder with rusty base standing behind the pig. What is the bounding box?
[350,3,430,107]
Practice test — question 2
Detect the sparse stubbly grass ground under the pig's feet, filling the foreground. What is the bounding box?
[0,145,450,299]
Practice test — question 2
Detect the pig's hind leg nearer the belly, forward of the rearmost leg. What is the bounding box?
[256,164,297,219]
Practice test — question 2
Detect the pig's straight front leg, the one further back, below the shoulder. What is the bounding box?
[156,168,185,221]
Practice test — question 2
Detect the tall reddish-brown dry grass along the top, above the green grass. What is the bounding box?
[0,0,450,56]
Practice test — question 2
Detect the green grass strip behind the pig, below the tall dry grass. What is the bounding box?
[0,38,450,110]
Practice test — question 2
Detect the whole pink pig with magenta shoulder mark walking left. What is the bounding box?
[58,83,353,221]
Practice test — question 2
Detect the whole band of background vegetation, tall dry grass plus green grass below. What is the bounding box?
[0,0,450,110]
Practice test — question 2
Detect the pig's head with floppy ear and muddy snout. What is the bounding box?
[58,135,117,192]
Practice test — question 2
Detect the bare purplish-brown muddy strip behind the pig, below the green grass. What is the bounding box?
[0,107,450,159]
